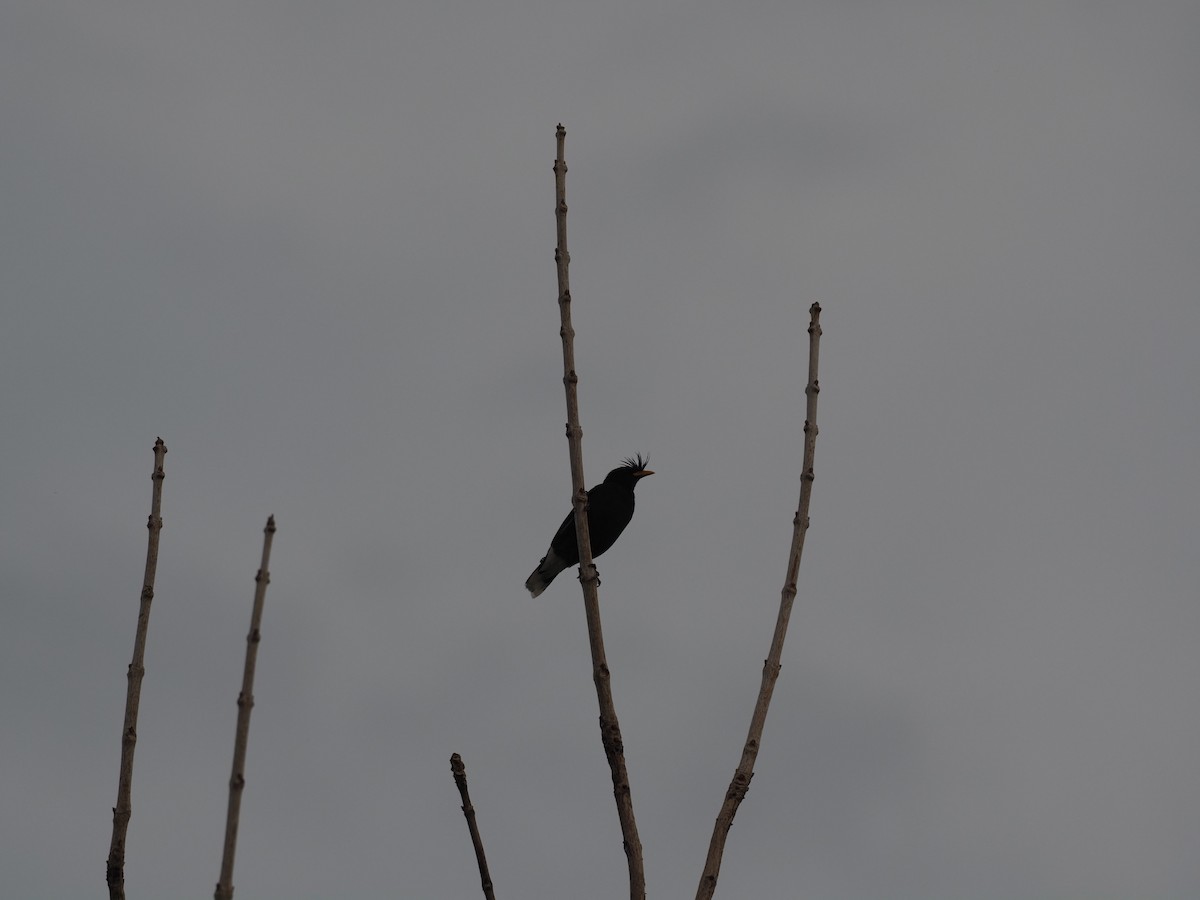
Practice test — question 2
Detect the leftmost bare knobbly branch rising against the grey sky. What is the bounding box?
[107,438,167,900]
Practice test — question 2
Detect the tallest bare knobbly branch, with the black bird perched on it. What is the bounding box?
[554,125,646,900]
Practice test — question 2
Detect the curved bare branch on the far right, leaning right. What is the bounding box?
[696,304,821,900]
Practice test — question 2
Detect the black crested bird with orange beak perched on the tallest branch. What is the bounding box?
[526,454,654,596]
